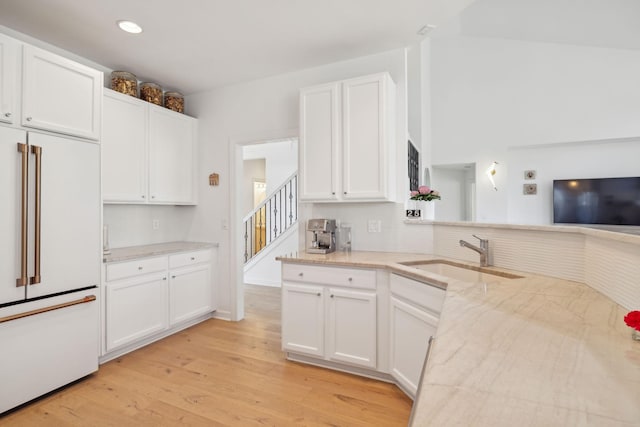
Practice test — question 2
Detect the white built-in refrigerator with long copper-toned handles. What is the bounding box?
[0,126,101,413]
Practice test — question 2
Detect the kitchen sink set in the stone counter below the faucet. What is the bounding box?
[400,260,523,282]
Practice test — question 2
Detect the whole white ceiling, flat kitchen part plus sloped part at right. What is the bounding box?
[0,0,640,94]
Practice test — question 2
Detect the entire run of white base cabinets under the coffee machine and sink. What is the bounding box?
[282,262,445,398]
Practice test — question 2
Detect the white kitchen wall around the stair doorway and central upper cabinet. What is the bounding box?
[188,49,416,317]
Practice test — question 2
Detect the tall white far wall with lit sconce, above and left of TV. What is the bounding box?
[430,36,640,223]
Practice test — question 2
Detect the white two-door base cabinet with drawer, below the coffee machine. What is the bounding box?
[282,263,377,369]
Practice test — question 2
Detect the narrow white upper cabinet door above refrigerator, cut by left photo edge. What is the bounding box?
[0,34,19,123]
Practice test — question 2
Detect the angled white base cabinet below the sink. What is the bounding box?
[390,274,445,397]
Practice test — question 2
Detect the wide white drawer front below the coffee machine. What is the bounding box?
[282,263,376,289]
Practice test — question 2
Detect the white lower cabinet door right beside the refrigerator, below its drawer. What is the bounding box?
[106,272,168,351]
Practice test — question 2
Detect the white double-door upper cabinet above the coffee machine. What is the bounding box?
[300,73,395,202]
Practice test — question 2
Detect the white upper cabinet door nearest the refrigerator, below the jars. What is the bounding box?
[102,90,148,203]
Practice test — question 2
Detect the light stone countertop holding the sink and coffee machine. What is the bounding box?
[277,252,640,427]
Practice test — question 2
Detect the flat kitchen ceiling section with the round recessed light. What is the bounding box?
[0,0,473,94]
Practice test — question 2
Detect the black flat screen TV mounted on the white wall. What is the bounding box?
[553,177,640,225]
